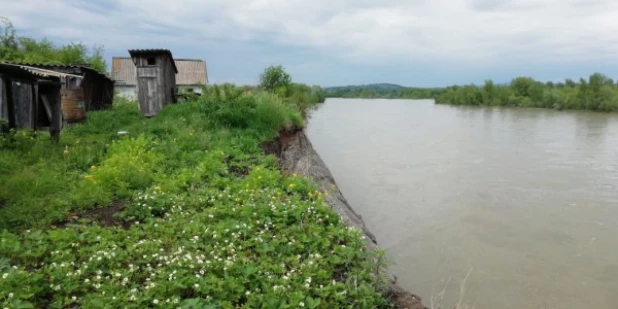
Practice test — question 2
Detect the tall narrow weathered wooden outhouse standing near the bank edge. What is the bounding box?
[129,49,178,117]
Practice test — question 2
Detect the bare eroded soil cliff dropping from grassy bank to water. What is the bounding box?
[262,130,427,309]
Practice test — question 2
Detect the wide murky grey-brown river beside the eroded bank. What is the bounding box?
[307,99,618,309]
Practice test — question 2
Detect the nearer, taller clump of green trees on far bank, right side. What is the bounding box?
[436,73,618,112]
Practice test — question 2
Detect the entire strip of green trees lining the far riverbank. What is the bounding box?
[326,73,618,111]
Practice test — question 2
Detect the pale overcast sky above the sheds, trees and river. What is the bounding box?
[0,0,618,86]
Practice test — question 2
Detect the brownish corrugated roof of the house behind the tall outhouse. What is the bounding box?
[112,57,208,86]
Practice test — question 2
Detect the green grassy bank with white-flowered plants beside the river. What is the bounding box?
[0,85,389,308]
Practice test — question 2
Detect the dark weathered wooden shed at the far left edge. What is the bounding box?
[0,63,67,140]
